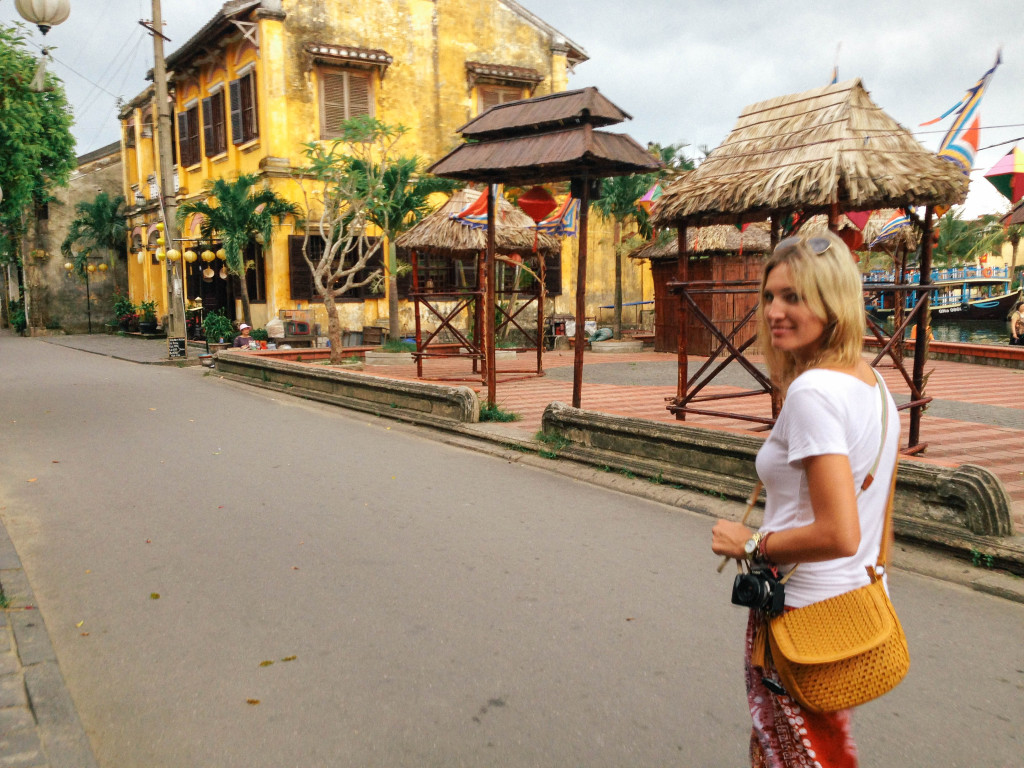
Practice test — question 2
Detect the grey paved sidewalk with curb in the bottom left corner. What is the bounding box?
[0,521,97,768]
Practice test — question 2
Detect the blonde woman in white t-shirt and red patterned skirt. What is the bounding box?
[712,233,899,768]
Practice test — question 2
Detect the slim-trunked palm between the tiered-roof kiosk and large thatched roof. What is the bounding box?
[591,143,693,339]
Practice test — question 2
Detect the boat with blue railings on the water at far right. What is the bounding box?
[863,266,1022,323]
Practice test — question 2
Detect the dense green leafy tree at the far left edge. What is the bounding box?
[0,25,75,323]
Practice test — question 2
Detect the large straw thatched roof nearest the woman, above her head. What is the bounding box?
[653,80,968,226]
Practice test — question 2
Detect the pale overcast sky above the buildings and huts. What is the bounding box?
[0,0,1024,216]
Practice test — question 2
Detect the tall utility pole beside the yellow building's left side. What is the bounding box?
[151,0,185,337]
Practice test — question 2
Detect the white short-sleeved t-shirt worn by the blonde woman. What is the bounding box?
[757,369,899,608]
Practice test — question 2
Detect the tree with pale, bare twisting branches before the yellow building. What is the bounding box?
[302,116,415,362]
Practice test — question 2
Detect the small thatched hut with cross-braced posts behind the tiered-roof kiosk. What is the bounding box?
[395,189,561,378]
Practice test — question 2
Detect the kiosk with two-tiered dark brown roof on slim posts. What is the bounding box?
[428,88,662,408]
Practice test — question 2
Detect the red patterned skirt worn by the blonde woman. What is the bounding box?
[743,610,857,768]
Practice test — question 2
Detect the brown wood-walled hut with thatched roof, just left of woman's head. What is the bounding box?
[629,223,771,355]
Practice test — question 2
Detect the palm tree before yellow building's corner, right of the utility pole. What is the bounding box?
[177,173,299,325]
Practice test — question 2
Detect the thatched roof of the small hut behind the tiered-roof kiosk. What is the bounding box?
[395,189,561,256]
